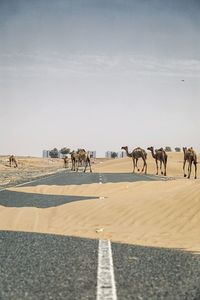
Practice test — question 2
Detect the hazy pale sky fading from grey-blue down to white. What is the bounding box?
[0,0,200,156]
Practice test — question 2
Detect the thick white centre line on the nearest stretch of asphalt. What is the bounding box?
[97,240,117,300]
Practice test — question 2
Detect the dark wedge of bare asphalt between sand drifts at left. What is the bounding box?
[0,190,98,208]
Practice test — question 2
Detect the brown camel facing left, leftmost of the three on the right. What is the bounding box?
[121,146,147,174]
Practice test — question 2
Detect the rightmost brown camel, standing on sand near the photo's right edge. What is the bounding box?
[183,147,197,179]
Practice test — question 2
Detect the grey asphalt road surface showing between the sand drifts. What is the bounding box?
[0,172,200,300]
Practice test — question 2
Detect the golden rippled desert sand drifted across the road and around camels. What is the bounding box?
[0,152,200,253]
